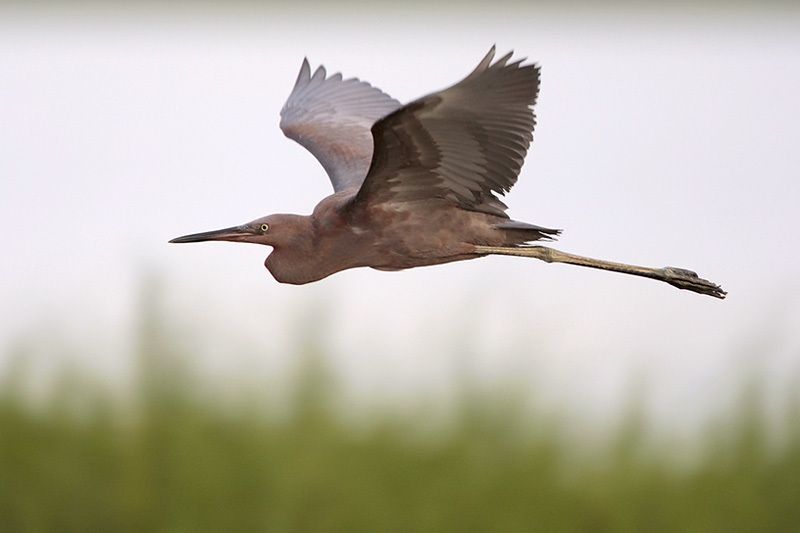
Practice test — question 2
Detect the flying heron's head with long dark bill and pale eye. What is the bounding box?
[169,215,308,247]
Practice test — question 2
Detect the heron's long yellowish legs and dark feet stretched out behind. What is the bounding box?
[475,246,727,299]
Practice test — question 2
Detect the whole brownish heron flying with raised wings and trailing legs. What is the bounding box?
[170,46,726,298]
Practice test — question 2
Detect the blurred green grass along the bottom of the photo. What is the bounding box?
[0,290,800,533]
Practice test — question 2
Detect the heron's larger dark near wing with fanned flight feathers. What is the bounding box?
[356,47,539,216]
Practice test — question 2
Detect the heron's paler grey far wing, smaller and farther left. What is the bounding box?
[281,59,400,191]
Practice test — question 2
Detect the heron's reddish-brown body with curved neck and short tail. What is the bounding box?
[259,190,554,284]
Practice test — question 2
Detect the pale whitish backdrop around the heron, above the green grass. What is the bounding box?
[0,4,800,430]
